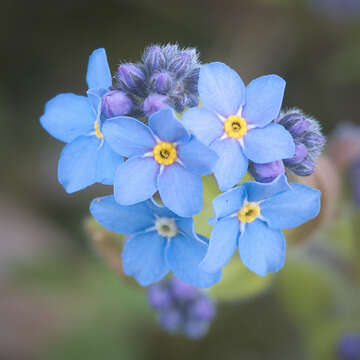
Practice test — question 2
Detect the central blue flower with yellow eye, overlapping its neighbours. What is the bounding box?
[103,108,218,217]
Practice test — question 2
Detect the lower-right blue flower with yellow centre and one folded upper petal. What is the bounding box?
[200,175,321,276]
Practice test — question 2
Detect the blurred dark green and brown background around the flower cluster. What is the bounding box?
[0,0,360,360]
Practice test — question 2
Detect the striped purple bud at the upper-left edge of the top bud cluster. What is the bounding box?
[117,63,146,93]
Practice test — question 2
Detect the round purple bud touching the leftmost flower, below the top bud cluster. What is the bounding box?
[101,90,133,117]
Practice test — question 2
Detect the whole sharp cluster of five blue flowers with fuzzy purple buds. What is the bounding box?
[40,45,324,287]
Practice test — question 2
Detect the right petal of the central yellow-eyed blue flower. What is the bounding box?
[177,137,219,175]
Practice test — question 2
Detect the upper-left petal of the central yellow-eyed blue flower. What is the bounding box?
[102,116,156,157]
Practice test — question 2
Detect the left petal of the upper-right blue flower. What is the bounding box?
[181,107,224,145]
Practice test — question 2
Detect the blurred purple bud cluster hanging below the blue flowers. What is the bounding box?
[148,277,216,339]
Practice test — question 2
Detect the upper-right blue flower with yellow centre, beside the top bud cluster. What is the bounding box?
[182,62,295,191]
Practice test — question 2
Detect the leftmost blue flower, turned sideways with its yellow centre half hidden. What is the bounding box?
[40,49,122,193]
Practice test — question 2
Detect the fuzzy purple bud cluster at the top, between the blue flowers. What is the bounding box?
[116,44,200,116]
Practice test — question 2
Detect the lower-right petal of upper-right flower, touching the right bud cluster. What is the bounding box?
[244,124,295,164]
